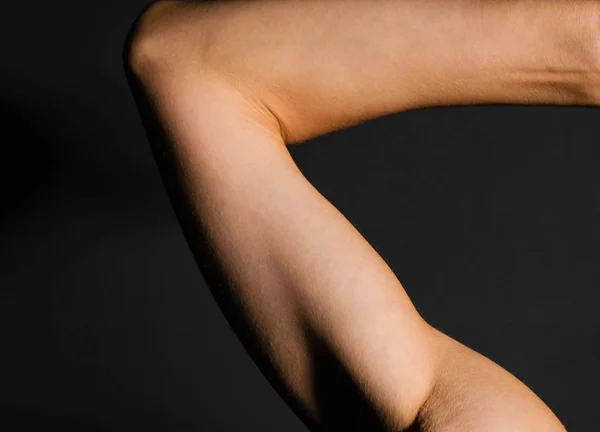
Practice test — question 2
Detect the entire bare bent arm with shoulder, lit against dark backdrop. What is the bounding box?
[126,0,600,432]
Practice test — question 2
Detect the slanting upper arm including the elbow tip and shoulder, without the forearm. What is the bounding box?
[127,3,564,432]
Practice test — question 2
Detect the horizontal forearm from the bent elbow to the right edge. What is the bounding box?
[130,0,600,144]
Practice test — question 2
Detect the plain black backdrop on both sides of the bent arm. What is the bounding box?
[0,0,600,431]
